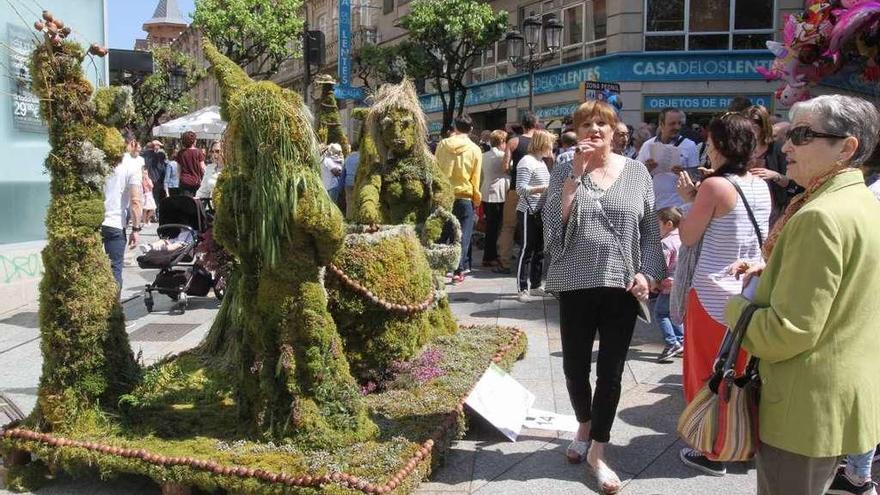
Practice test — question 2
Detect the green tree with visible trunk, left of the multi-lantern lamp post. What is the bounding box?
[400,0,507,131]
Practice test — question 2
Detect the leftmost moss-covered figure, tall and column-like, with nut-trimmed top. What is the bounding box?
[28,12,140,431]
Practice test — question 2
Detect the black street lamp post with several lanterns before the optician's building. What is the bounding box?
[504,16,562,112]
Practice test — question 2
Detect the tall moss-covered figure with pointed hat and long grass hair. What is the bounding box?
[205,42,378,446]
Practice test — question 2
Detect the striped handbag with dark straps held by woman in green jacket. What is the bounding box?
[678,304,761,462]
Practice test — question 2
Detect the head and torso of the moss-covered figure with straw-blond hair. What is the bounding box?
[350,79,454,231]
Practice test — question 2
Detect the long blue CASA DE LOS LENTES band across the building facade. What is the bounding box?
[420,50,773,113]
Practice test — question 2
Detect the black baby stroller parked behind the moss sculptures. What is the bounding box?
[137,196,223,312]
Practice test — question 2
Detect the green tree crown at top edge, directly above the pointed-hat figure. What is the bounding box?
[193,0,304,79]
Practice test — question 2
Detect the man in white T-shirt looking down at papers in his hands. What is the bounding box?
[636,108,700,211]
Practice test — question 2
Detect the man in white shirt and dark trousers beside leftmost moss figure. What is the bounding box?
[101,133,144,289]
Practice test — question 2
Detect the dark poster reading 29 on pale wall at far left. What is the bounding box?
[6,23,46,133]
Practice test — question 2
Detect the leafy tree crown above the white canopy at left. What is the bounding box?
[133,47,205,140]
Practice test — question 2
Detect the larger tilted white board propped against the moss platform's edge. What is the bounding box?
[465,364,535,442]
